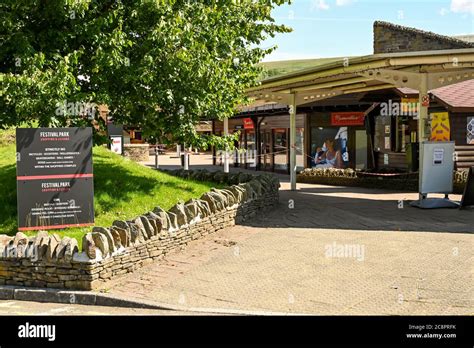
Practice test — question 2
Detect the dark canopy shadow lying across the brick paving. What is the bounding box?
[244,185,474,234]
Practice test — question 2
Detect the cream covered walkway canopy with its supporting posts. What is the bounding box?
[247,48,474,190]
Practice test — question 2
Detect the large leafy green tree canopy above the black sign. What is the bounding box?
[0,0,290,145]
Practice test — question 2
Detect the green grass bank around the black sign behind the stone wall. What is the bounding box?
[0,133,220,250]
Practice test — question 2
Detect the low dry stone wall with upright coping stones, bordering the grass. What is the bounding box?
[0,170,280,290]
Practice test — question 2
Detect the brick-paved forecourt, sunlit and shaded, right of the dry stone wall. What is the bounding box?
[101,155,474,315]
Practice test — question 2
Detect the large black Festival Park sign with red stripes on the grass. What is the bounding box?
[16,128,94,231]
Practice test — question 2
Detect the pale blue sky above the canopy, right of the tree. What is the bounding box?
[262,0,474,61]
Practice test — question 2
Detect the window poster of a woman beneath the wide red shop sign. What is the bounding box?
[311,127,349,169]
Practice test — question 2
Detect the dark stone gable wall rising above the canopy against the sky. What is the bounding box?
[374,21,474,54]
